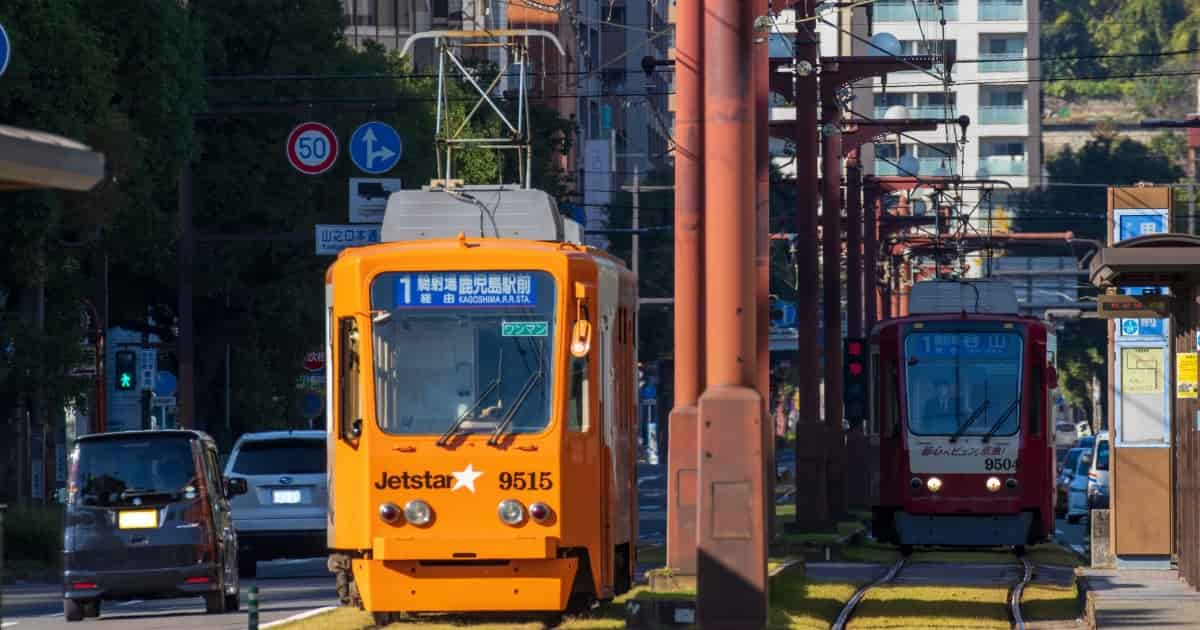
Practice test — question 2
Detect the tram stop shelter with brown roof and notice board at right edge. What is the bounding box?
[1090,219,1200,588]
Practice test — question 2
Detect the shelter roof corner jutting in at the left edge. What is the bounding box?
[0,125,104,192]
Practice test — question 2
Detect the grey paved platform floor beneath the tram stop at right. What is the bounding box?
[1082,569,1200,629]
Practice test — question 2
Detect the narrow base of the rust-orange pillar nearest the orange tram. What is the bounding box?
[667,407,700,575]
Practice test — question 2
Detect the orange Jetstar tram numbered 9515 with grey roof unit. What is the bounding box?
[325,186,637,624]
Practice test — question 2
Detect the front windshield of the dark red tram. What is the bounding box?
[905,330,1021,436]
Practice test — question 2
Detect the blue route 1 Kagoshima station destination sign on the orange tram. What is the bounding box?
[395,271,538,308]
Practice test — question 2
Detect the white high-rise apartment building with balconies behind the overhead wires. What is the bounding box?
[871,0,1042,199]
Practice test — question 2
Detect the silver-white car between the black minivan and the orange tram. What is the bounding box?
[226,431,329,577]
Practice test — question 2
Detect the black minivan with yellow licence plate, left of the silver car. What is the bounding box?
[62,431,246,622]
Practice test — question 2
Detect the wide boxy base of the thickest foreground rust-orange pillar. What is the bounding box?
[696,385,767,628]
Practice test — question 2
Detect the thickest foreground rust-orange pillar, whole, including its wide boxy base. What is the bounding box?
[696,0,767,628]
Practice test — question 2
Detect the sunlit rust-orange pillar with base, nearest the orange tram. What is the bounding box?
[666,1,704,575]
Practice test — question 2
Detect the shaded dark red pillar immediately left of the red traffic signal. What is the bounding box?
[821,103,846,517]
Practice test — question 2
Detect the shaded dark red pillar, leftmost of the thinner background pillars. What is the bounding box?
[793,0,830,529]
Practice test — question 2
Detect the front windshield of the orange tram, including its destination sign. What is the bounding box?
[371,271,554,436]
